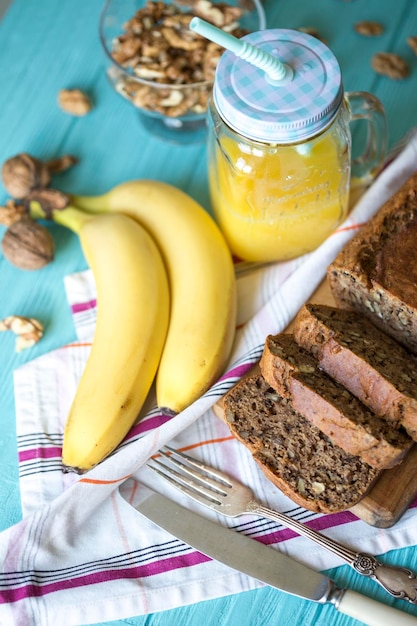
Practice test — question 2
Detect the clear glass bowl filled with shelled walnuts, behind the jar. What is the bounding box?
[100,0,265,143]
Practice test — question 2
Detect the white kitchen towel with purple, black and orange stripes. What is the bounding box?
[0,129,417,626]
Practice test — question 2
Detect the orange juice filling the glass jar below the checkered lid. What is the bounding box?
[208,117,350,261]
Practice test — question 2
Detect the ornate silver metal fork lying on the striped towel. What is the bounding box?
[148,446,417,604]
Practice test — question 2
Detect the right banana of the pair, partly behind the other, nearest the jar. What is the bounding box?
[72,180,236,413]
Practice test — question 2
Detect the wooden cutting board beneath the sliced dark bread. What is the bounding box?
[215,281,417,528]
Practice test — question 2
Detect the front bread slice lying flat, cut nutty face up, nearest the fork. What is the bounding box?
[224,374,378,513]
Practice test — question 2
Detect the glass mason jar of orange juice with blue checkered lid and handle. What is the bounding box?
[208,29,387,262]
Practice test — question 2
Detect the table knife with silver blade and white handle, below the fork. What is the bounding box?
[135,492,417,626]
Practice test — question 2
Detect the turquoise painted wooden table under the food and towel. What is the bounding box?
[0,0,417,626]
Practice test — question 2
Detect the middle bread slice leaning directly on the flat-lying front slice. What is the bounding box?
[260,334,413,469]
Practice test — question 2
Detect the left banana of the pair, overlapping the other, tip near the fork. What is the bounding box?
[30,202,169,473]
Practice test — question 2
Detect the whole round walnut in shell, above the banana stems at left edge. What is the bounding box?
[1,152,51,199]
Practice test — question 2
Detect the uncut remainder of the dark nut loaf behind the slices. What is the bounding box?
[327,172,417,354]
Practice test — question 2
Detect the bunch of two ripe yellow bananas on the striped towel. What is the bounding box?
[30,180,236,473]
